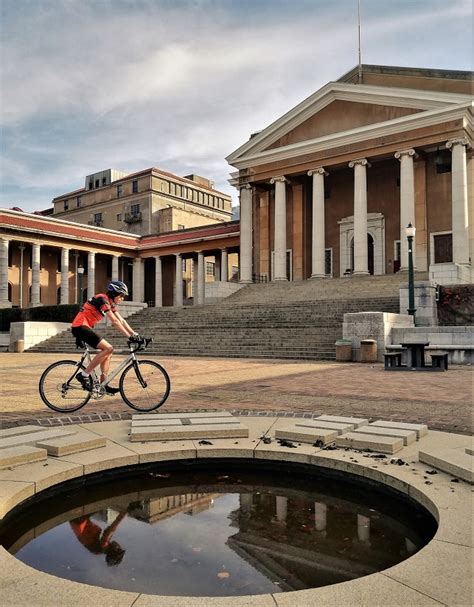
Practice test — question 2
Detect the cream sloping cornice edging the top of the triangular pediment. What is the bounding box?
[226,82,472,167]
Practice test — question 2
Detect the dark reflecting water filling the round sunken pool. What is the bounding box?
[0,473,434,596]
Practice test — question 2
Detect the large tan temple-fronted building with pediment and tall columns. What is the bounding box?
[227,65,474,284]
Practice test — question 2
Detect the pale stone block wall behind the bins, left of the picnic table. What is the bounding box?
[342,312,414,362]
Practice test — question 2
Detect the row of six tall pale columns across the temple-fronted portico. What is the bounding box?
[240,138,469,283]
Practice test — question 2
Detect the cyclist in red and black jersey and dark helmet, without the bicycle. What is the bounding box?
[71,280,140,394]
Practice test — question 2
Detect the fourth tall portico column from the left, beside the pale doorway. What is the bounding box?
[349,158,370,276]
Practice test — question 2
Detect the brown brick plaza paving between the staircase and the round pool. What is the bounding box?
[0,352,473,434]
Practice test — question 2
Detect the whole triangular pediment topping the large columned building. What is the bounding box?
[227,82,471,166]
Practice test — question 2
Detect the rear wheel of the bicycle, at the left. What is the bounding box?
[39,360,91,413]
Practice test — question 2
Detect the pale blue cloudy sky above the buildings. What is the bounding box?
[0,0,473,210]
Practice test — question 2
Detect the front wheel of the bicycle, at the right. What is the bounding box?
[119,360,171,411]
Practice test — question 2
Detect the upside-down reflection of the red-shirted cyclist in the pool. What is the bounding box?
[69,512,127,565]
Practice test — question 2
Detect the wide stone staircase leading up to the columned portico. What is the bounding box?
[28,277,399,360]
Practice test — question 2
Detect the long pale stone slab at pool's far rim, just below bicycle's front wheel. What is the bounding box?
[130,423,249,442]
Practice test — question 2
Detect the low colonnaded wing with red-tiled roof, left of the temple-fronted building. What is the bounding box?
[0,209,239,308]
